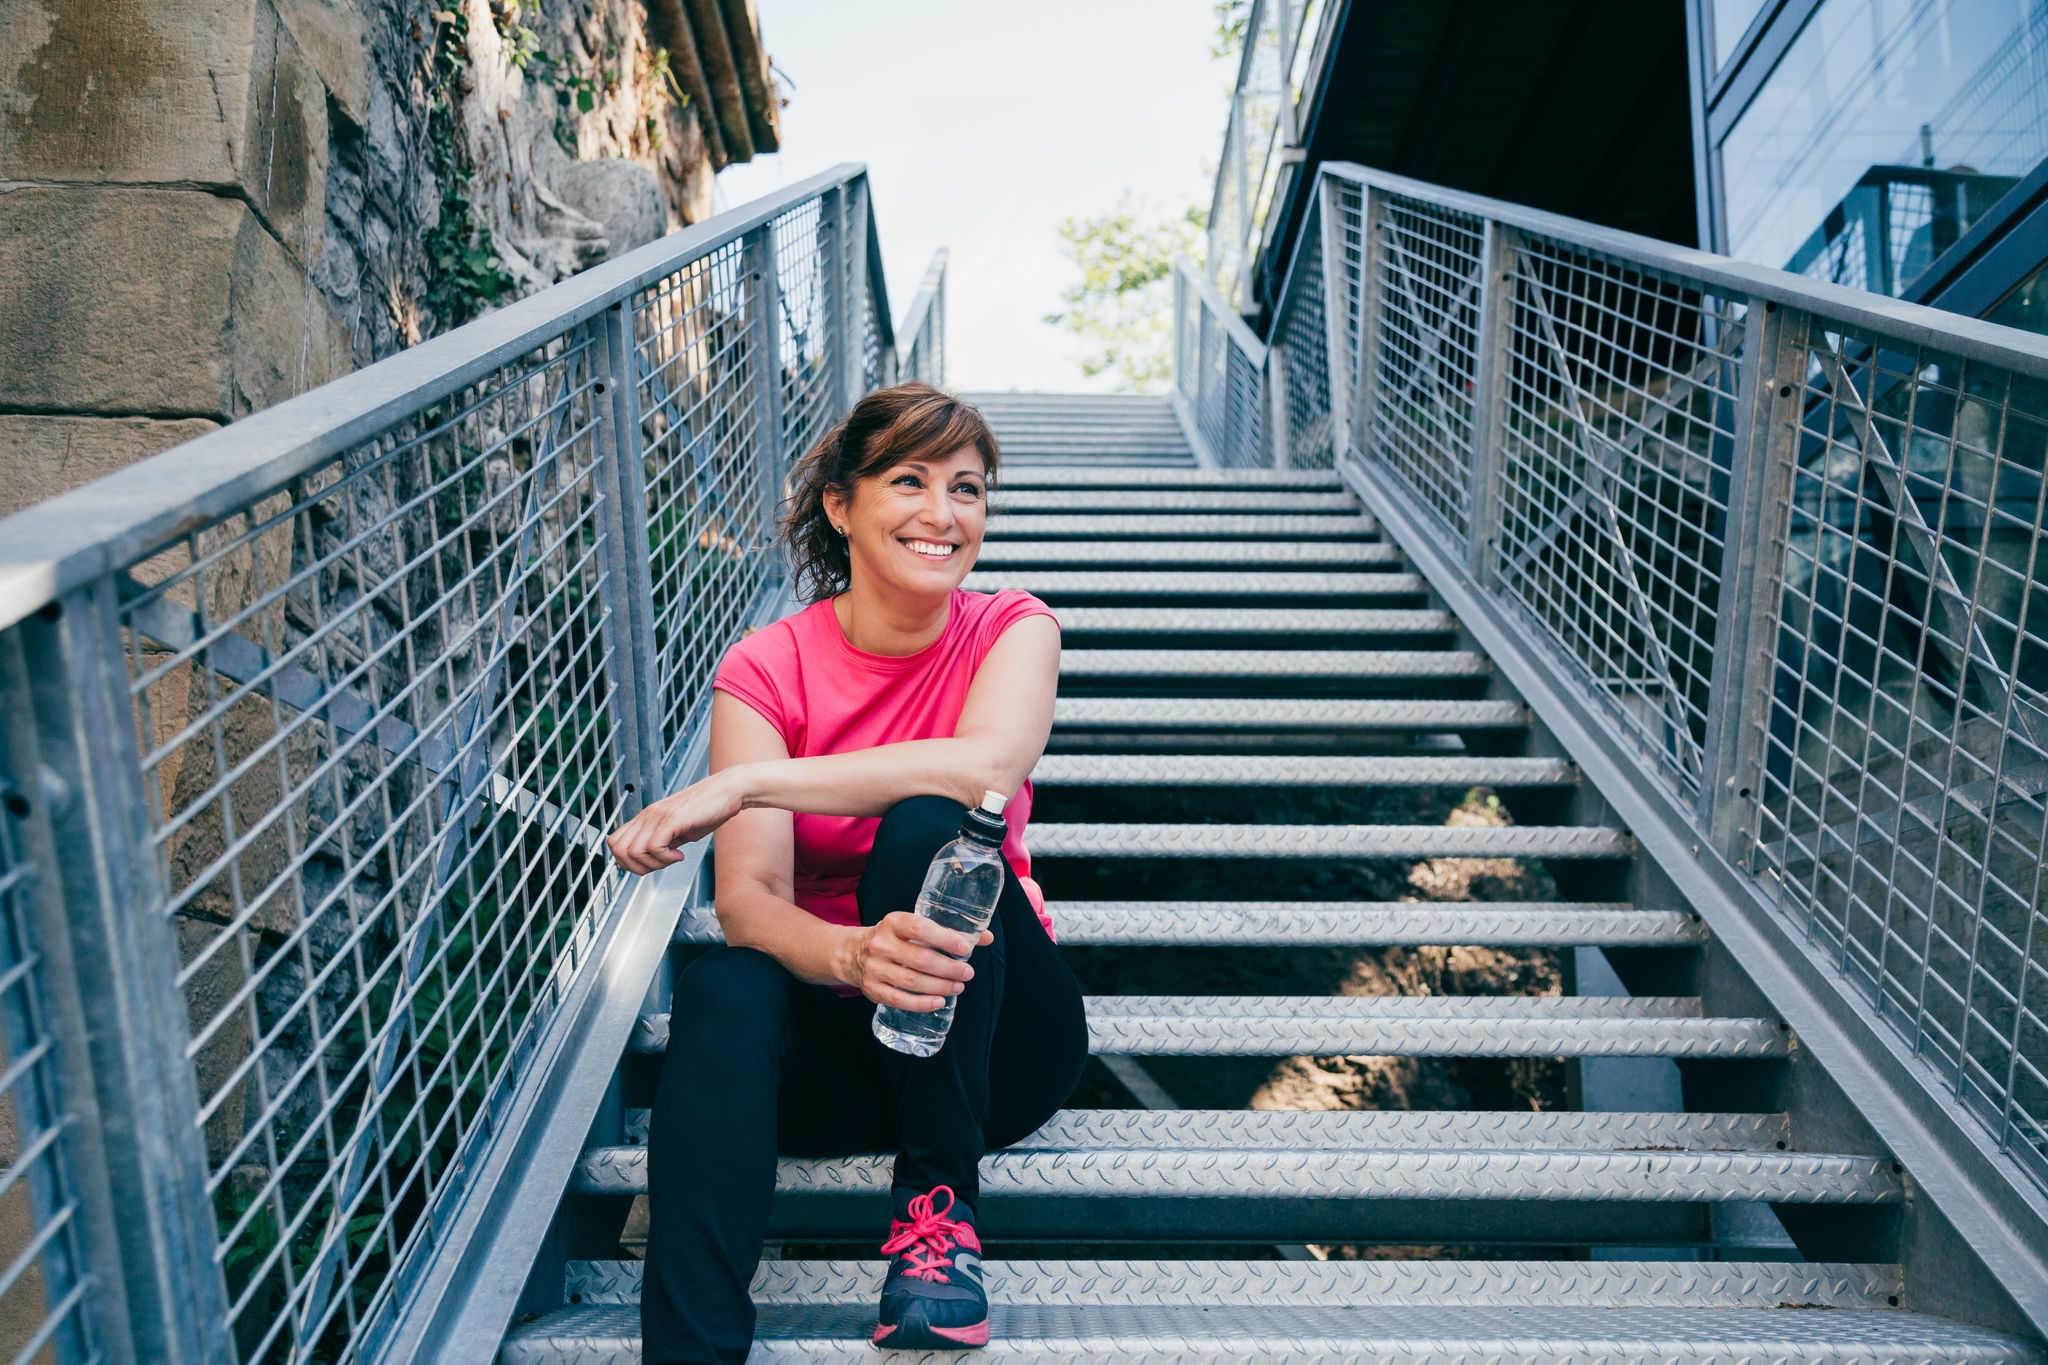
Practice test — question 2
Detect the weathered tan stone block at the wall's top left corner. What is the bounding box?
[0,0,328,264]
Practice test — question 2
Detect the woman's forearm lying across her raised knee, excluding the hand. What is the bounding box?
[719,739,1036,814]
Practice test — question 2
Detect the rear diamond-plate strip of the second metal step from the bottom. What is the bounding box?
[606,1109,1792,1152]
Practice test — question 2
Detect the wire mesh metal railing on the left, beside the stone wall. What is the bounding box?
[0,168,921,1363]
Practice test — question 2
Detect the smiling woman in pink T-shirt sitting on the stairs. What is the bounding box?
[610,383,1087,1365]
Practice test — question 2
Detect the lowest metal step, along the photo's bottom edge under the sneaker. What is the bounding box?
[498,1304,2042,1365]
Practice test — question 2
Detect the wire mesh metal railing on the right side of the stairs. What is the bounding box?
[1176,166,2048,1285]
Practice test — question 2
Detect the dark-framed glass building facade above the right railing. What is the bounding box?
[1688,0,2048,332]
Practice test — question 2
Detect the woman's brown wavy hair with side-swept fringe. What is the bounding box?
[782,383,1001,602]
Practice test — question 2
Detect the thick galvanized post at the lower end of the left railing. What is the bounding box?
[20,579,233,1365]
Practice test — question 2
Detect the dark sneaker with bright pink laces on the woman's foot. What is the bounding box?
[874,1185,989,1351]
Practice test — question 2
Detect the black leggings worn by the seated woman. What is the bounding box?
[641,796,1087,1365]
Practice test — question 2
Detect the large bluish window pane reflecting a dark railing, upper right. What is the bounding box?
[1720,0,2048,295]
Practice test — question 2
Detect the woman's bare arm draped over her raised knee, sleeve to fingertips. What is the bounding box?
[610,616,1059,880]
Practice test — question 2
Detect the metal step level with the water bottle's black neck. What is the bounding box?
[1026,825,1634,860]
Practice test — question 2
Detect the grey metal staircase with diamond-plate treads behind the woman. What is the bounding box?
[500,395,2038,1365]
